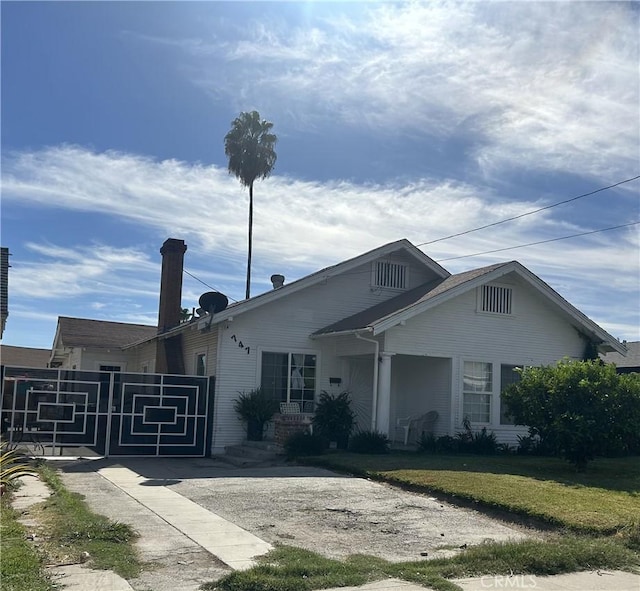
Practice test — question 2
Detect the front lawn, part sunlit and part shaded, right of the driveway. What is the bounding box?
[311,453,640,534]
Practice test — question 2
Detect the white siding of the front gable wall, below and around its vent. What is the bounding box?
[385,274,585,443]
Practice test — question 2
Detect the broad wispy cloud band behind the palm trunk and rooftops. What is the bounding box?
[2,146,640,338]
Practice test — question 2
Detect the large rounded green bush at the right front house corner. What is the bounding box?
[502,360,640,469]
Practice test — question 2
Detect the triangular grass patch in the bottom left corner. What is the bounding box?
[0,493,54,591]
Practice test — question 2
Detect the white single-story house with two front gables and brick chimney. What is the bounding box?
[43,239,626,453]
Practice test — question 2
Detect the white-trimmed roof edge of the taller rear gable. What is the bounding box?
[190,238,451,336]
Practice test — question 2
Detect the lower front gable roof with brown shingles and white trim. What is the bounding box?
[312,261,626,354]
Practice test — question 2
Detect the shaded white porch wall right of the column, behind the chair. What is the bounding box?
[389,355,451,441]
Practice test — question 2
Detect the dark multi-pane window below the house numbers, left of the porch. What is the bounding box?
[260,351,316,408]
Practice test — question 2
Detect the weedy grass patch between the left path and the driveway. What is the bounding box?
[34,466,142,579]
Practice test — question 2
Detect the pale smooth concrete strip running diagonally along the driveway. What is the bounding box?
[98,466,273,570]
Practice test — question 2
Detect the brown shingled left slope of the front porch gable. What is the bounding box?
[312,263,508,337]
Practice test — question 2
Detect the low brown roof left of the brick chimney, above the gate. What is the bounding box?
[56,316,158,348]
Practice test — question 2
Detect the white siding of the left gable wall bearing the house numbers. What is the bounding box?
[212,257,435,453]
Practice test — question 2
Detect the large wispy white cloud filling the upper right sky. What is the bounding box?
[147,2,640,178]
